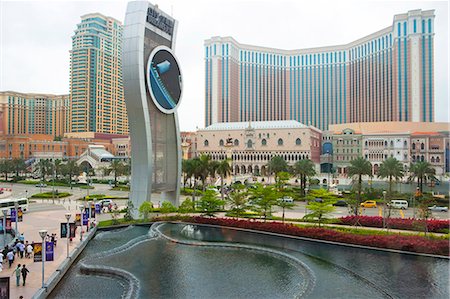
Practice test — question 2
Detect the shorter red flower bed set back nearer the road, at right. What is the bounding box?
[339,216,450,233]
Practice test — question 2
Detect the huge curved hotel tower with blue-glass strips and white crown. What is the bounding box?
[205,10,434,129]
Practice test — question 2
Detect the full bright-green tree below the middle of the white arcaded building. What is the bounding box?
[249,184,278,221]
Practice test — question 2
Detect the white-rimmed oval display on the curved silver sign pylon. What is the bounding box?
[147,46,183,114]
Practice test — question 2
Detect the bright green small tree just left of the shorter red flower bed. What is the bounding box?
[304,189,336,226]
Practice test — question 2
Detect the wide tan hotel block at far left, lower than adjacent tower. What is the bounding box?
[0,91,69,136]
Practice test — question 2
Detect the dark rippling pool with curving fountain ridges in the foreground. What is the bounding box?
[49,222,449,298]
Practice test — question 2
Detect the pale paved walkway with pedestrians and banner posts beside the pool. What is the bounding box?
[0,208,89,298]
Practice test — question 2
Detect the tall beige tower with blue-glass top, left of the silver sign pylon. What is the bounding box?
[70,13,128,134]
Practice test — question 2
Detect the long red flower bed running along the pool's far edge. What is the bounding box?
[185,217,449,256]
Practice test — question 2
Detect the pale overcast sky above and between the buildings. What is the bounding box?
[0,0,449,131]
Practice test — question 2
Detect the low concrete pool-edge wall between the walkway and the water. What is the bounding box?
[32,227,97,299]
